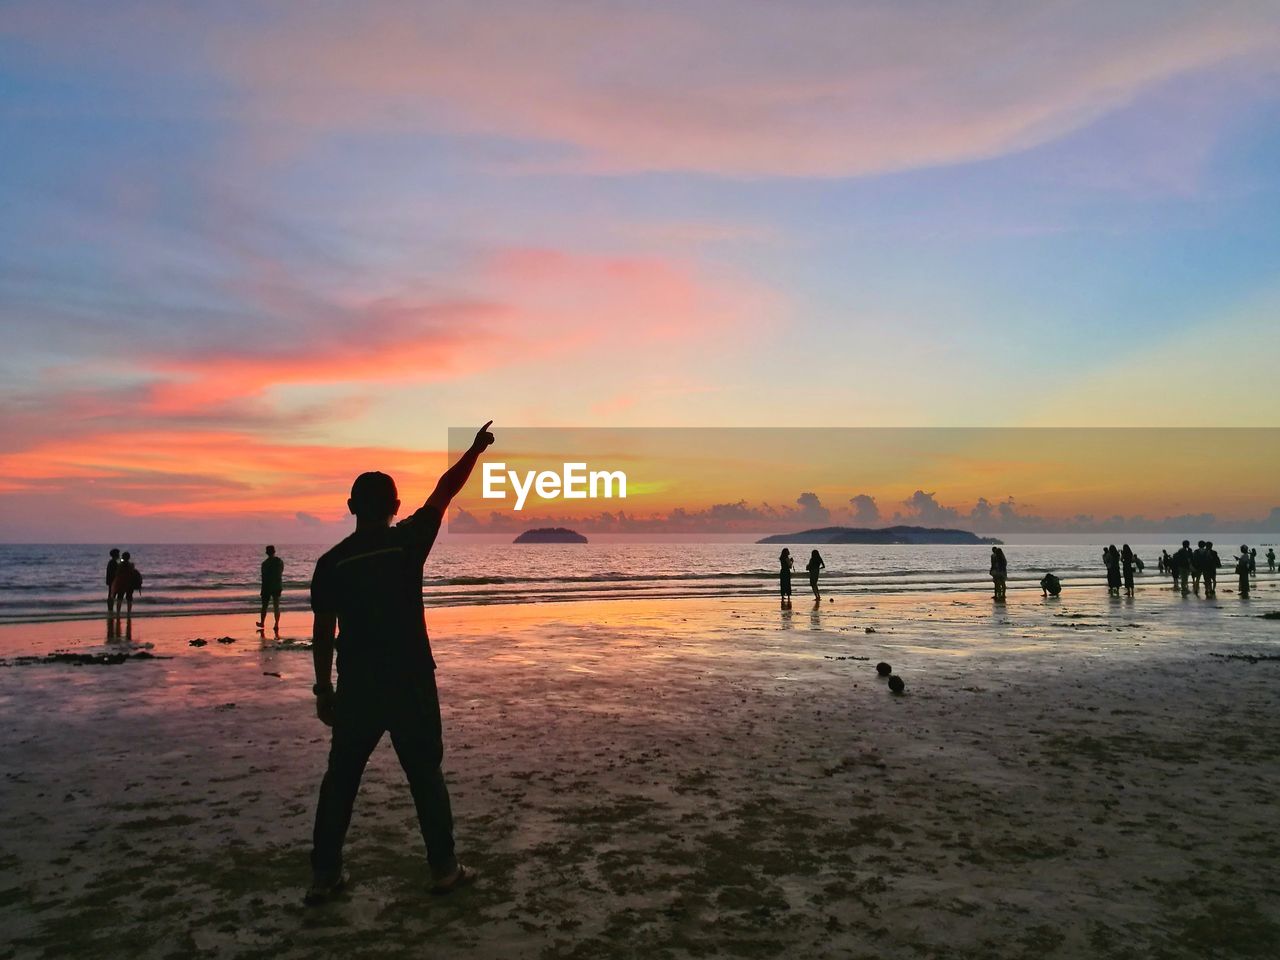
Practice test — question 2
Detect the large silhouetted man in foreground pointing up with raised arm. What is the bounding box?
[306,420,493,904]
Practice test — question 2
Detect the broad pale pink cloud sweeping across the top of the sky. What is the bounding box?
[211,0,1280,175]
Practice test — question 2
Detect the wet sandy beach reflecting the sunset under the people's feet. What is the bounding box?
[0,576,1280,959]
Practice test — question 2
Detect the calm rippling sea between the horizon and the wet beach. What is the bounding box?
[0,534,1276,623]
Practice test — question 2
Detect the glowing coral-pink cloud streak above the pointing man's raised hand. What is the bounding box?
[120,241,776,415]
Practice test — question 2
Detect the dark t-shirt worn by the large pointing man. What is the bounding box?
[311,506,440,681]
